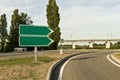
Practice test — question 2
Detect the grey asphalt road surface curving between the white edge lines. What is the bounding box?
[62,52,120,80]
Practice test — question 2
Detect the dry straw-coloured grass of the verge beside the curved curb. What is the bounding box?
[0,51,79,80]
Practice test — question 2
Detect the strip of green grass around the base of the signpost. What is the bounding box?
[0,56,53,66]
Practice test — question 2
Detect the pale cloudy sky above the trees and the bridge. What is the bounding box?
[0,0,120,39]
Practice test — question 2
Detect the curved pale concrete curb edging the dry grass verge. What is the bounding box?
[46,53,81,80]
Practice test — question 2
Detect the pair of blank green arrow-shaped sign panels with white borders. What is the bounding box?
[19,25,53,47]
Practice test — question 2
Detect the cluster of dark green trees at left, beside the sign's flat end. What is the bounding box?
[0,9,32,52]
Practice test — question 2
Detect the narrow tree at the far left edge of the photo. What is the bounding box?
[0,14,7,52]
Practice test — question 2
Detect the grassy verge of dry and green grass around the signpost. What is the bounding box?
[0,51,79,80]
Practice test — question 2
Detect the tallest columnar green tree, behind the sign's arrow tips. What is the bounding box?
[46,0,61,49]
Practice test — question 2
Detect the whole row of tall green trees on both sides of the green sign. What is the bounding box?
[0,0,61,52]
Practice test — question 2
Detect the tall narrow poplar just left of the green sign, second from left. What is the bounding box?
[10,9,20,49]
